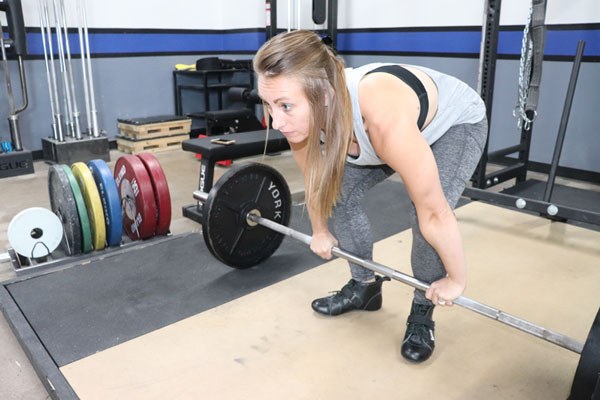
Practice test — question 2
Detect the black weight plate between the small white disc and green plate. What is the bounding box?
[48,164,82,256]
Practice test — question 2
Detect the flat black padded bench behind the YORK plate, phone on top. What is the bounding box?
[181,129,290,223]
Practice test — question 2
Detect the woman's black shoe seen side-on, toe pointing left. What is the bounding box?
[311,276,390,315]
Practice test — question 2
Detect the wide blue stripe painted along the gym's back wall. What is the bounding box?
[22,27,600,58]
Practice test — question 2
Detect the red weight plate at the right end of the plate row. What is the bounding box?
[137,153,171,235]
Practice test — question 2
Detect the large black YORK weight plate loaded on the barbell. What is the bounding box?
[202,163,292,269]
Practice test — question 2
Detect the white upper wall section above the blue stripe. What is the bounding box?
[11,0,600,29]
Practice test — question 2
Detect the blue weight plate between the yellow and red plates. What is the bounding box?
[88,159,123,247]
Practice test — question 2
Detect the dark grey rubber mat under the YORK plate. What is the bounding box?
[0,180,428,367]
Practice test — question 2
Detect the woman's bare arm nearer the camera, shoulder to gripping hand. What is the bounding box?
[360,74,467,303]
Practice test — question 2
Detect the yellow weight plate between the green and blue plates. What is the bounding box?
[71,162,106,250]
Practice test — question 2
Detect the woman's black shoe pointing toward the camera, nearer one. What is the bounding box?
[402,301,435,363]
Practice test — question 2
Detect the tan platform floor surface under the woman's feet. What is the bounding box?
[61,202,600,400]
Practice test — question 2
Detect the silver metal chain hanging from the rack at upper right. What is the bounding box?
[513,1,535,130]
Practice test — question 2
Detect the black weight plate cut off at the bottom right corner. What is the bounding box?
[569,309,600,400]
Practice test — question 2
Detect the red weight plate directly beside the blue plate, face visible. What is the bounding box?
[114,155,157,240]
